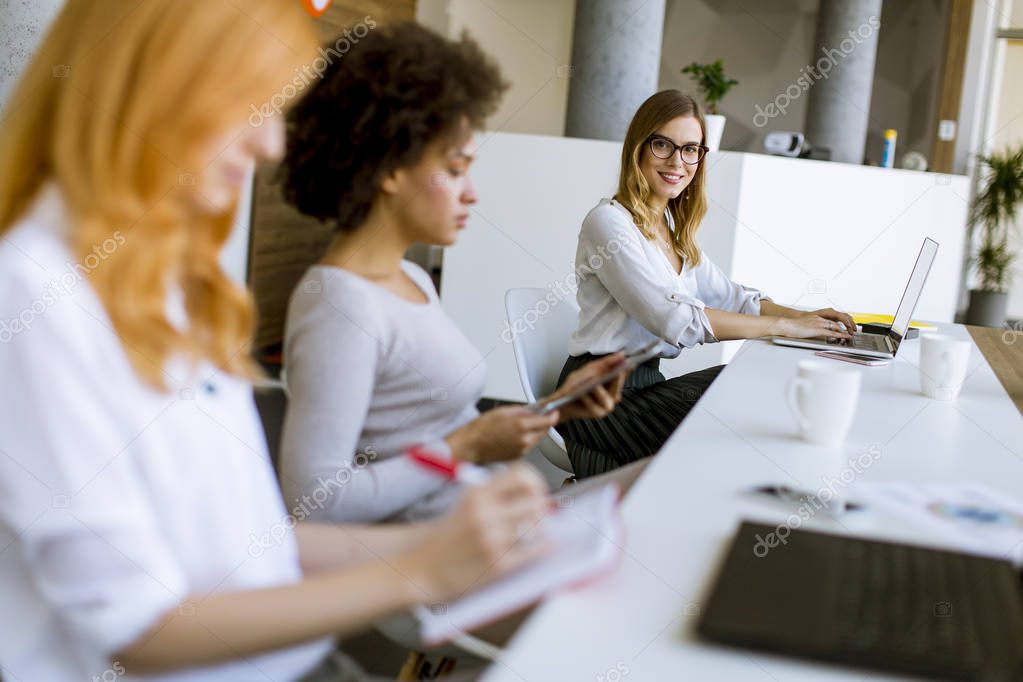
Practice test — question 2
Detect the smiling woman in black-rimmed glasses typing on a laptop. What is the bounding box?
[558,90,855,476]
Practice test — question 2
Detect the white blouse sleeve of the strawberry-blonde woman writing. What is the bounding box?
[0,289,188,656]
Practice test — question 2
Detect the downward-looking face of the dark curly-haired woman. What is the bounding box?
[382,130,477,246]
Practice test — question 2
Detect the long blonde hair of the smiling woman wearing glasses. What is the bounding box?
[615,90,707,267]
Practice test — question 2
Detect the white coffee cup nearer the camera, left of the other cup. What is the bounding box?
[787,360,860,445]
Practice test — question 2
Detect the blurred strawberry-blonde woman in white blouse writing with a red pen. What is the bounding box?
[0,0,549,682]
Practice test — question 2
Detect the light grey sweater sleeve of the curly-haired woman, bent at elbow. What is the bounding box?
[281,280,444,522]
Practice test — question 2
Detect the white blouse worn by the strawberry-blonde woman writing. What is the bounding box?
[0,184,332,682]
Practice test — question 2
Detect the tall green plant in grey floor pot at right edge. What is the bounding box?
[966,146,1023,327]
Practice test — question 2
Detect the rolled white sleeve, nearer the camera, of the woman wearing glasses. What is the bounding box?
[577,209,717,348]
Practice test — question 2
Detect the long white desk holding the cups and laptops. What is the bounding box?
[484,324,1023,682]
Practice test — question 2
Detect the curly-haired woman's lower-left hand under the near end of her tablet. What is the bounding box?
[445,405,560,464]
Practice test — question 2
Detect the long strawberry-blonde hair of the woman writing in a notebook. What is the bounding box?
[0,0,316,388]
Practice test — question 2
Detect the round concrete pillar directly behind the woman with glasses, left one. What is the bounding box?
[565,0,665,141]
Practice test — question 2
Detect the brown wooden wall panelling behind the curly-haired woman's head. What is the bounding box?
[249,0,415,350]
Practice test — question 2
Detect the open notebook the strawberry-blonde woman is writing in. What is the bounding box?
[419,484,624,646]
